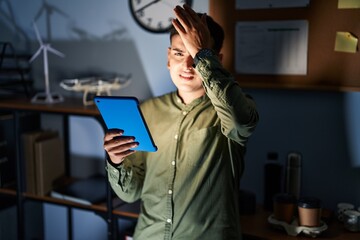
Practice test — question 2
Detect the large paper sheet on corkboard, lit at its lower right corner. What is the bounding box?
[235,20,308,75]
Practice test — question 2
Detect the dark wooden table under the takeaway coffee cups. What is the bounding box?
[241,207,360,240]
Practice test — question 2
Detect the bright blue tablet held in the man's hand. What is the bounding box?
[94,96,157,152]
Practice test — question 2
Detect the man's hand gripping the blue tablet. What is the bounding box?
[104,129,139,164]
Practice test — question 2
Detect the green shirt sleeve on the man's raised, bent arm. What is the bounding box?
[196,56,259,145]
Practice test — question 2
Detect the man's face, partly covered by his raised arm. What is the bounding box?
[167,34,205,99]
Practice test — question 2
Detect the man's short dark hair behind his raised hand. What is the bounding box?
[169,13,225,53]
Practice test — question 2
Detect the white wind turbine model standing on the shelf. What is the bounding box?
[30,22,65,103]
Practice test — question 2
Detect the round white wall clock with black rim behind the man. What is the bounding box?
[130,0,192,33]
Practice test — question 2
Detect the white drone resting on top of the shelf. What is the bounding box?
[60,75,131,106]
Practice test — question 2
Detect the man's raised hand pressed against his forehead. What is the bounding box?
[172,4,212,58]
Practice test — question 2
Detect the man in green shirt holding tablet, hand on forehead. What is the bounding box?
[104,5,259,240]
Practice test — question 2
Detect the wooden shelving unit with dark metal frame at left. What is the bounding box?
[0,98,139,239]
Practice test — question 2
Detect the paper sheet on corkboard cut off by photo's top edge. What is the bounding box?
[236,0,310,9]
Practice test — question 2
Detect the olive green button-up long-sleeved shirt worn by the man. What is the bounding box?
[108,54,258,240]
